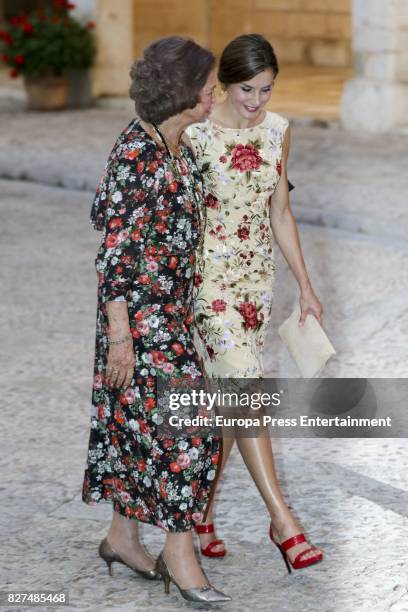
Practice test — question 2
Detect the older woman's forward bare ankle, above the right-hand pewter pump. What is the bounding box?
[163,530,208,589]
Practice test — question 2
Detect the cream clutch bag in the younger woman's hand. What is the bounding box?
[278,308,336,378]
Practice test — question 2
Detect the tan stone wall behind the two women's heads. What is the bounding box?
[133,0,351,66]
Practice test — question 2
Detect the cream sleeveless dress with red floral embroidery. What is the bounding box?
[187,112,288,378]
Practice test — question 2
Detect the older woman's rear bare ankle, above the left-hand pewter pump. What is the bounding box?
[107,512,155,570]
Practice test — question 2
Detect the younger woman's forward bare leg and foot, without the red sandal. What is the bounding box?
[237,436,322,560]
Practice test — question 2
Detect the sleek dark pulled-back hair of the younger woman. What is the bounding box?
[218,34,279,86]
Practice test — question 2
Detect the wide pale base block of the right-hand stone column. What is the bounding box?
[341,77,408,133]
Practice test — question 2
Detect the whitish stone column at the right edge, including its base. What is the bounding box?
[342,0,408,132]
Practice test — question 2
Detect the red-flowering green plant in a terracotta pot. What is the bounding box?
[0,0,95,110]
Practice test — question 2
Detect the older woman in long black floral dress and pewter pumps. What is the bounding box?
[83,37,229,601]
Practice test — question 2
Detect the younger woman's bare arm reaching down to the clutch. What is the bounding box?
[270,128,323,325]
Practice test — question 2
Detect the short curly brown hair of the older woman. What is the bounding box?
[130,36,215,123]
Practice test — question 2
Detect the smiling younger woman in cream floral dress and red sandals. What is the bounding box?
[187,34,322,569]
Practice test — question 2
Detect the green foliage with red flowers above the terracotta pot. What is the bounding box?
[0,0,95,77]
